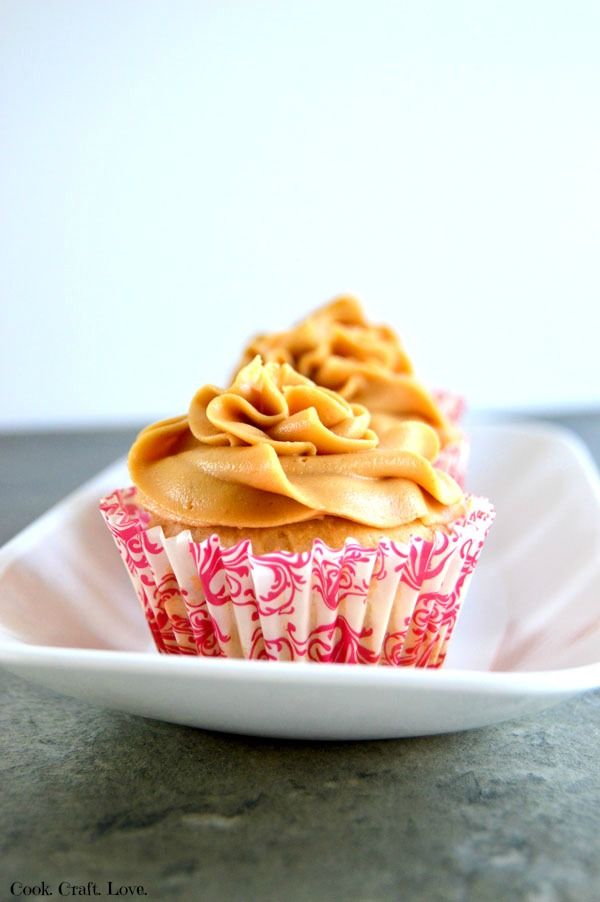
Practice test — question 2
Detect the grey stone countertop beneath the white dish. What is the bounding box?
[0,414,600,902]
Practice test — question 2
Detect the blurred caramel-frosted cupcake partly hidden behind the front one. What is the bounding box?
[237,297,468,485]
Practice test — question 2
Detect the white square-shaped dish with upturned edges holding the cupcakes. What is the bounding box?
[0,424,600,739]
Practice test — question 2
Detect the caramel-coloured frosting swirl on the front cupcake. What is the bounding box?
[128,358,463,529]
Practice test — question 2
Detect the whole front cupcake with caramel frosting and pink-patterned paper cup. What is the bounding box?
[100,356,493,667]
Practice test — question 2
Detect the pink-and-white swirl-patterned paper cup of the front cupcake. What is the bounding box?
[100,488,494,667]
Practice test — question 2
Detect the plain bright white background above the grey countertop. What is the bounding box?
[0,0,600,427]
